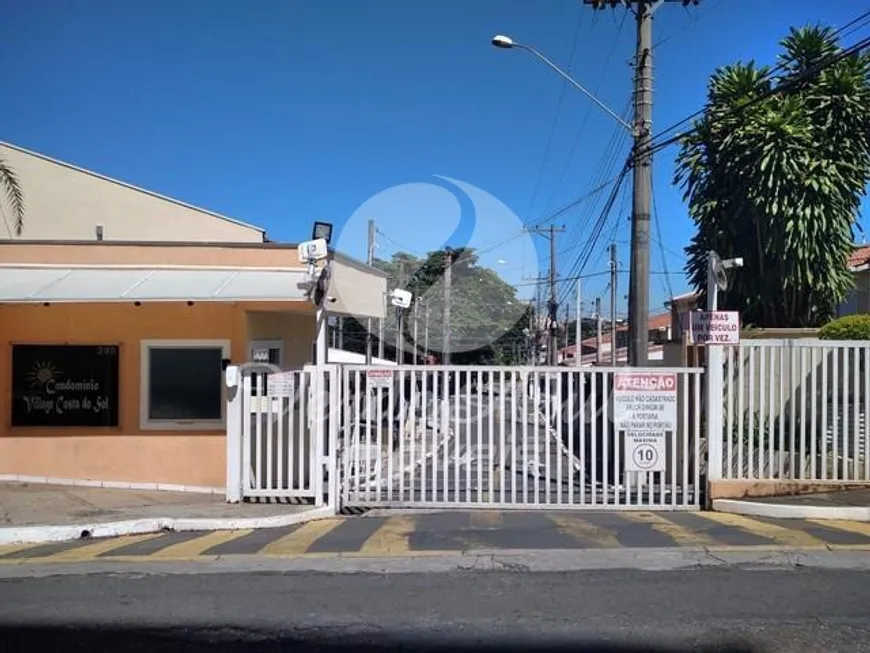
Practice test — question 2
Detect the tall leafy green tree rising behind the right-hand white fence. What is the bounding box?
[675,26,870,327]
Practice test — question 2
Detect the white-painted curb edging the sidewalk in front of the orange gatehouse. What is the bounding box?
[0,507,335,545]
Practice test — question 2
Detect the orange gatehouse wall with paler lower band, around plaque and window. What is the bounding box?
[0,302,313,487]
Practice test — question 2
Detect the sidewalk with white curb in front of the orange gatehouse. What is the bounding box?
[0,482,333,544]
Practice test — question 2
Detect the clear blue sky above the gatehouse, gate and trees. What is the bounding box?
[0,0,866,313]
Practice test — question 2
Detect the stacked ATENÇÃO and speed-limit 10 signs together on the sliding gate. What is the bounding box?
[613,372,677,472]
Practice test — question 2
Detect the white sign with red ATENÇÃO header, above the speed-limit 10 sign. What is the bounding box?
[613,372,677,433]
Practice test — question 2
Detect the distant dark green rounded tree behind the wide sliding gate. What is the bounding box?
[344,248,531,364]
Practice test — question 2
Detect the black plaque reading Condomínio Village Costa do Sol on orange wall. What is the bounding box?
[12,345,118,427]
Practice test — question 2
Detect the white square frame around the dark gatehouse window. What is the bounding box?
[139,339,230,431]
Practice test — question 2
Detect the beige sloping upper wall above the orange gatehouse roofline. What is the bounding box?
[0,143,264,243]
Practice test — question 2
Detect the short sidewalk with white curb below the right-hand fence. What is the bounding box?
[713,489,870,522]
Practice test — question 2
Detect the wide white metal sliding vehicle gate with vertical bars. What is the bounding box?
[339,366,702,510]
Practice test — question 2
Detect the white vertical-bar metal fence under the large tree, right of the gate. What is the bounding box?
[722,340,870,482]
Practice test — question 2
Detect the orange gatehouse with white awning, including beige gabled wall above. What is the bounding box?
[0,145,386,489]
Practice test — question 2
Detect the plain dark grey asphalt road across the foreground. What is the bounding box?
[0,567,870,653]
